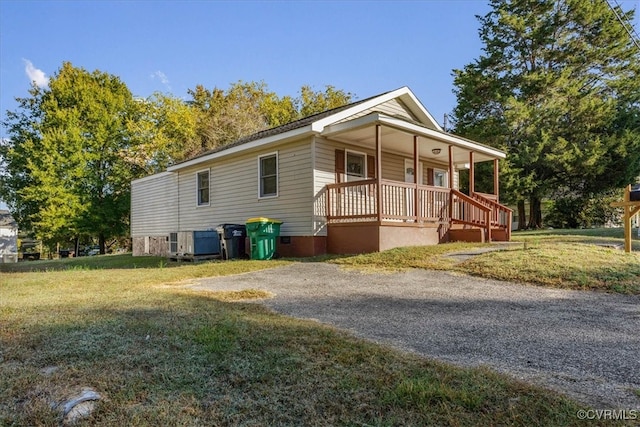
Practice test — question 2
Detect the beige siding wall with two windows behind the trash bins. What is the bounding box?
[179,138,313,236]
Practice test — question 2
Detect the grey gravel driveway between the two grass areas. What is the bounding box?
[192,263,640,409]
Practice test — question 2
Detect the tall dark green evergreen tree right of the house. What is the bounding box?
[454,0,640,227]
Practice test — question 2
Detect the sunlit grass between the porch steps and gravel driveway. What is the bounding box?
[328,229,640,295]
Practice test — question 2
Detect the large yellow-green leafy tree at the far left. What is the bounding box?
[0,62,144,253]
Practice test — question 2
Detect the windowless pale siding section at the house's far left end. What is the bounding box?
[131,172,178,237]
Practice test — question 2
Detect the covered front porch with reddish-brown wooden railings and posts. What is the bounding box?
[323,114,512,253]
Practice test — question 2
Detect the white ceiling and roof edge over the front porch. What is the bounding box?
[321,114,505,168]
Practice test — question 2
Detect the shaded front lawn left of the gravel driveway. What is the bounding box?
[0,256,608,426]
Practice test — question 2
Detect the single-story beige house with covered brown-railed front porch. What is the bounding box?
[131,87,512,256]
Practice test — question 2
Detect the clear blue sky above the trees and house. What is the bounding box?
[0,0,640,136]
